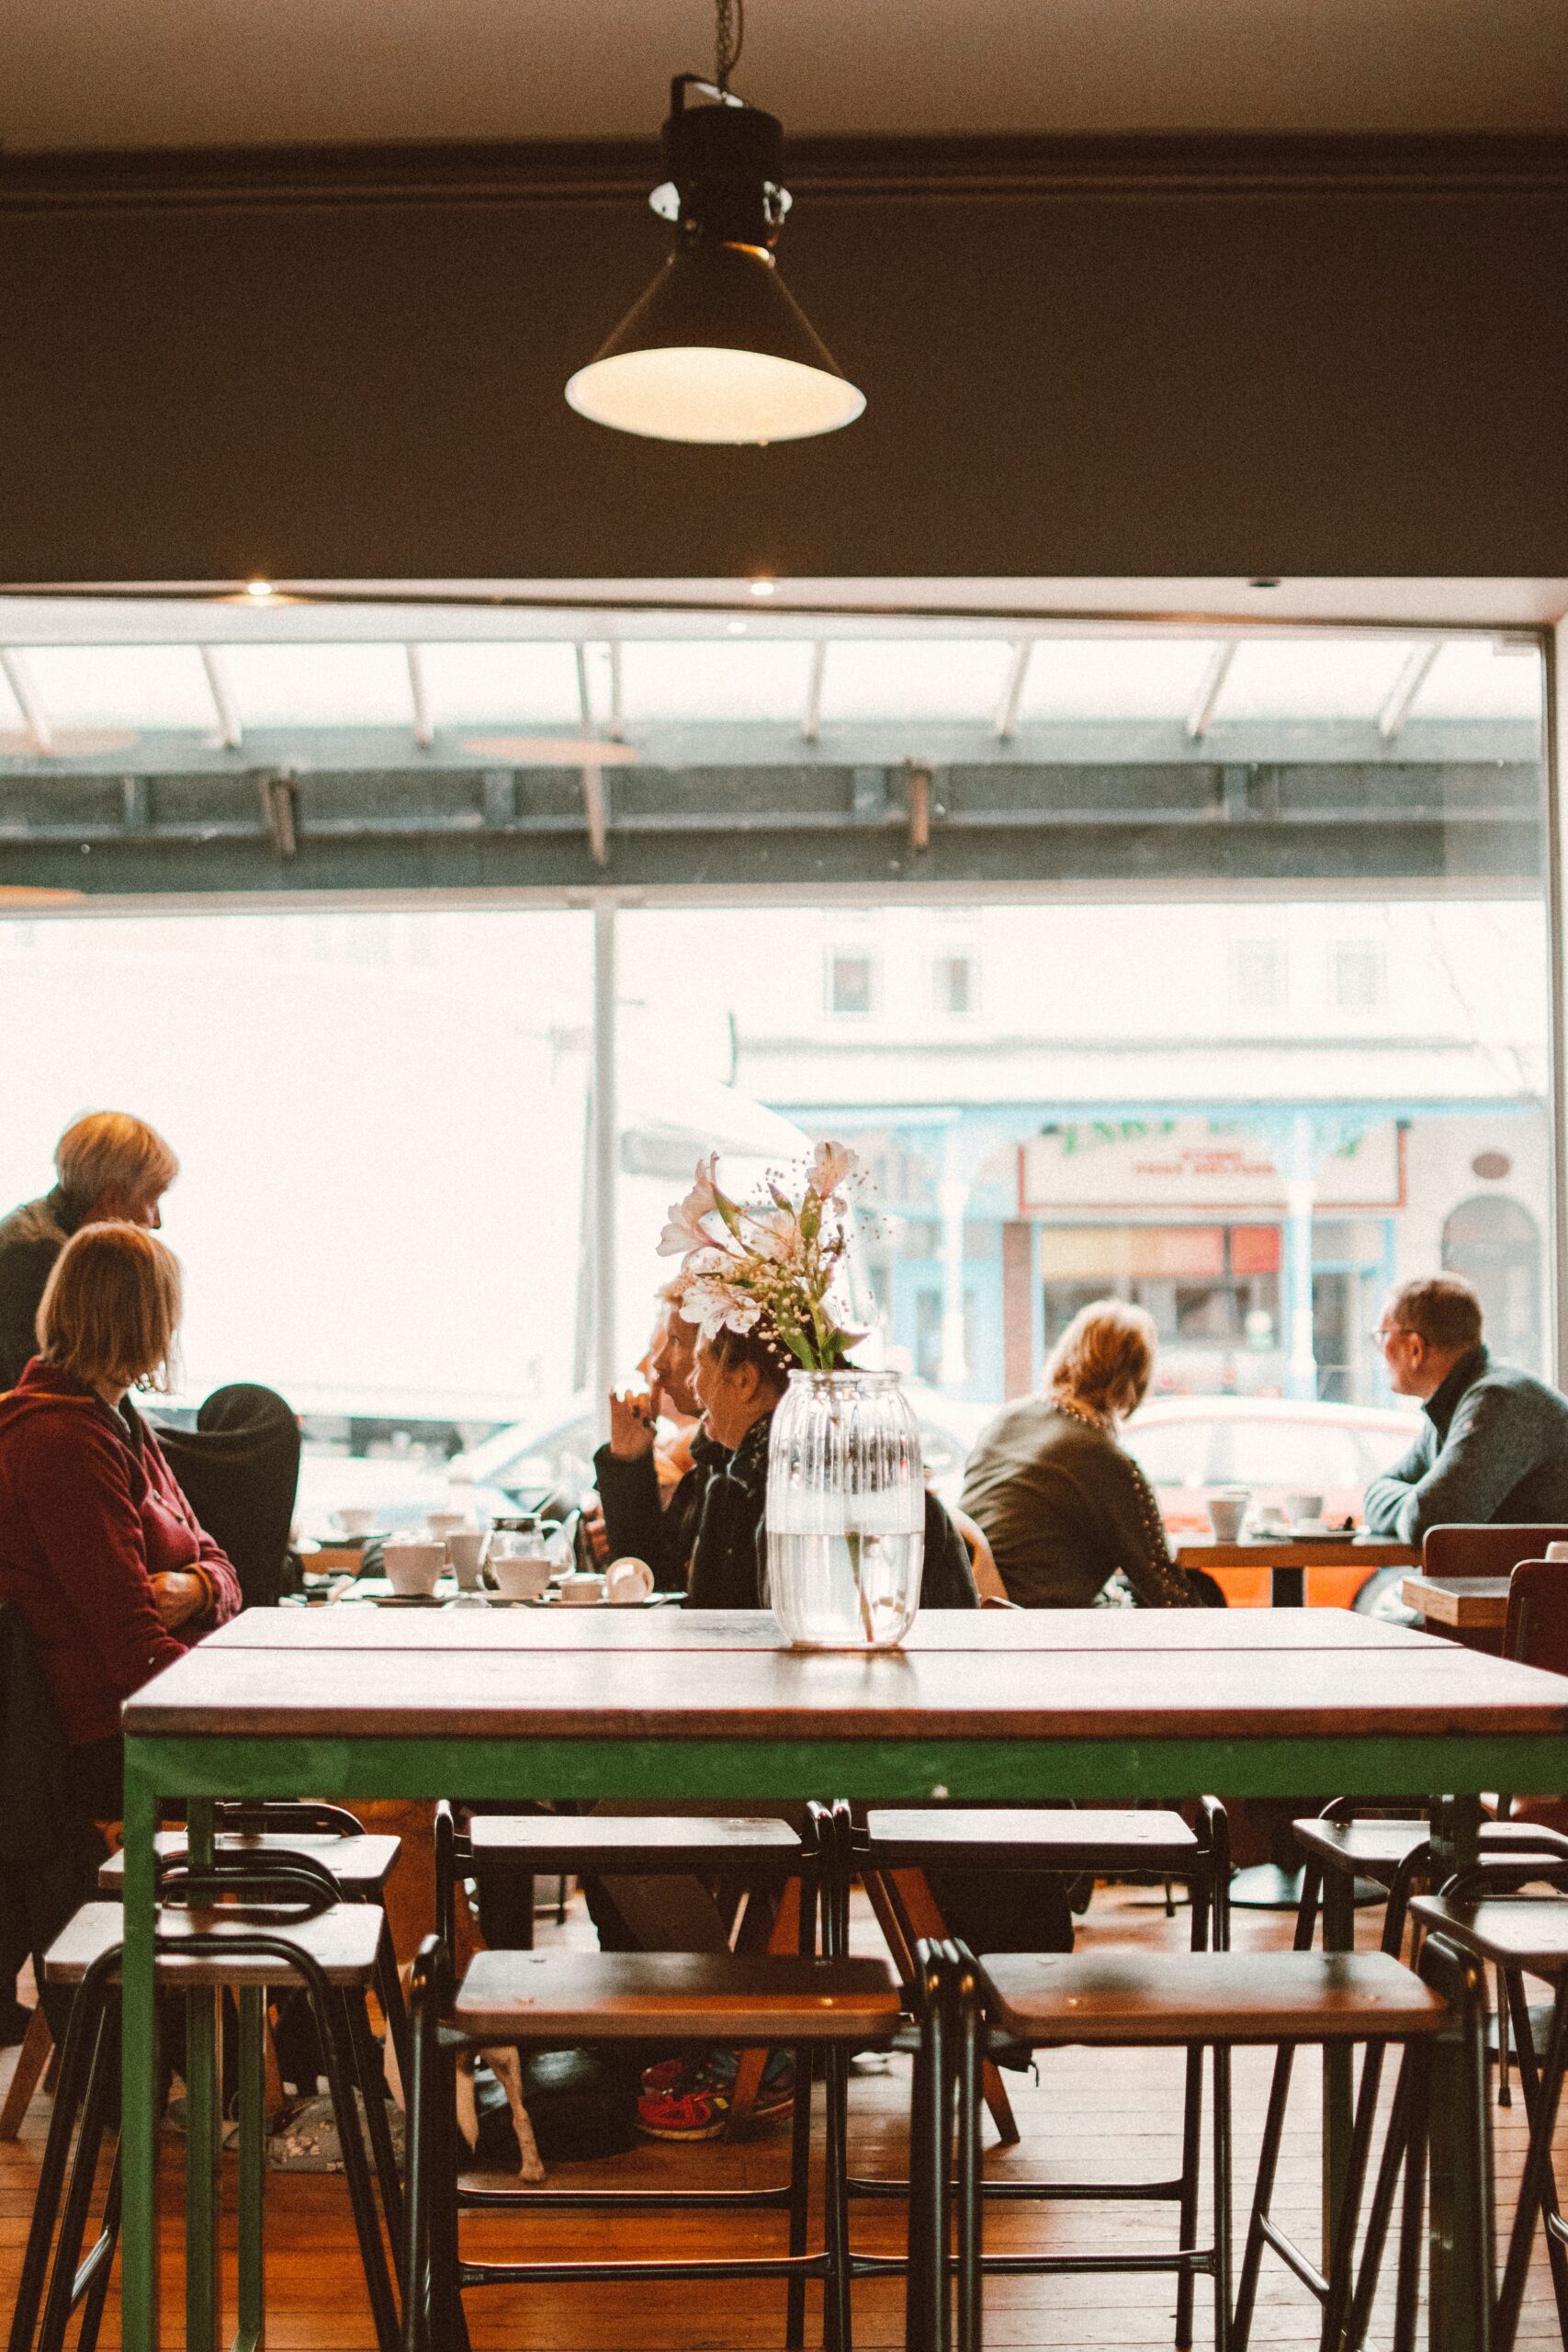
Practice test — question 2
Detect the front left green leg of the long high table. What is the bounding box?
[120,1747,157,2352]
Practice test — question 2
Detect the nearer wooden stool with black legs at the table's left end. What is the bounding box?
[9,1858,402,2352]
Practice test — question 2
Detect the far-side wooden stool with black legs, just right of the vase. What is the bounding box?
[851,1797,1229,2347]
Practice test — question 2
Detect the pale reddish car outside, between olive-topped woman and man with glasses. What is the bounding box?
[1123,1397,1420,1613]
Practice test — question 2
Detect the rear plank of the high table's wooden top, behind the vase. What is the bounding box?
[202,1601,1427,1656]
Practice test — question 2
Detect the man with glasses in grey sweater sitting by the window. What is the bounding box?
[1366,1275,1568,1543]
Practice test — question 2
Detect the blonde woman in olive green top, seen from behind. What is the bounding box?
[964,1298,1203,1609]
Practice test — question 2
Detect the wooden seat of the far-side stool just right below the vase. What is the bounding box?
[865,1806,1199,1877]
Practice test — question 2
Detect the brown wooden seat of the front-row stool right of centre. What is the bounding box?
[980,1947,1448,2046]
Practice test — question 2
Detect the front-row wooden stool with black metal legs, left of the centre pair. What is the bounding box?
[404,1936,900,2352]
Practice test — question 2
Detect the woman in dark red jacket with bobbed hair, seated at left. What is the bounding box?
[0,1226,240,1820]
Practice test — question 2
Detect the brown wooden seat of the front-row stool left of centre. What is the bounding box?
[451,1952,900,2044]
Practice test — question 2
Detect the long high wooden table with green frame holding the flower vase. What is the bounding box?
[122,1609,1568,2352]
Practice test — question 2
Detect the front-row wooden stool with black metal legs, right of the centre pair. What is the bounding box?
[926,1943,1483,2352]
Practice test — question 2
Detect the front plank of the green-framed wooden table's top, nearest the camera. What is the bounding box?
[125,1611,1568,1747]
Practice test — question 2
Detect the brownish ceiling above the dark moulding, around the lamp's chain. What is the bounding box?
[12,0,1568,153]
